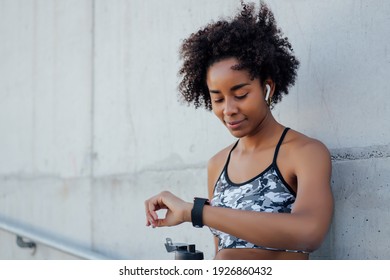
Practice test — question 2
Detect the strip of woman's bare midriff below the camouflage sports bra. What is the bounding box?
[214,249,309,260]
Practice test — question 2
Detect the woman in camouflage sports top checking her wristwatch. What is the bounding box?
[145,4,333,259]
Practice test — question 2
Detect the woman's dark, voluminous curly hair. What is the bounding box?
[179,2,299,110]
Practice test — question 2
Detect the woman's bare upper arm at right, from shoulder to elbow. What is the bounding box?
[292,140,333,247]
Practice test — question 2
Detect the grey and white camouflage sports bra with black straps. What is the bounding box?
[210,128,306,253]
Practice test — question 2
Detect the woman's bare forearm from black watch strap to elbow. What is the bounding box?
[203,206,322,251]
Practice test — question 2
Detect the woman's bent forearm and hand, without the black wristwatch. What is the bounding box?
[145,192,331,251]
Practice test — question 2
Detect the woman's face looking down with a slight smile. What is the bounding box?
[206,58,272,138]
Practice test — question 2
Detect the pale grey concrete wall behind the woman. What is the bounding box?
[0,0,390,259]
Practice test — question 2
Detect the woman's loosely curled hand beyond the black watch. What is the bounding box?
[145,191,192,228]
